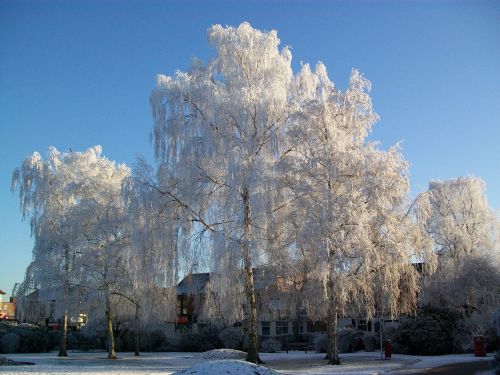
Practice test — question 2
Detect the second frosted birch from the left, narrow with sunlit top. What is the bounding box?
[71,148,132,359]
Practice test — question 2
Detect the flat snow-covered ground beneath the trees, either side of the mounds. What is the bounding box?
[0,352,493,375]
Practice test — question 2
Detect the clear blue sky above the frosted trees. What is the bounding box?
[0,0,500,300]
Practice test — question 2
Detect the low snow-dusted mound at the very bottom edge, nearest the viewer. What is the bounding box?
[174,359,279,375]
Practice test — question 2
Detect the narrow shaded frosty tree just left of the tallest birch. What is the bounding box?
[117,165,180,352]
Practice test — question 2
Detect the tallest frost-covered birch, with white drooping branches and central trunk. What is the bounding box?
[151,23,292,362]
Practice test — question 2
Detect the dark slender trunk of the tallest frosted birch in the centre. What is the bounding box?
[242,188,263,363]
